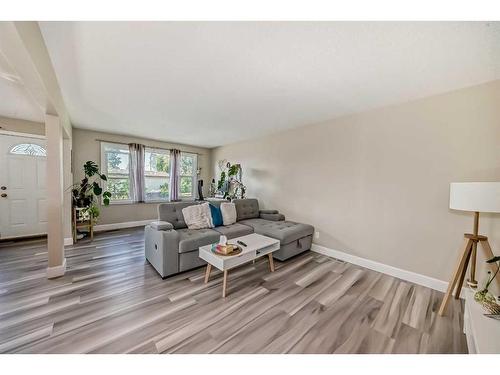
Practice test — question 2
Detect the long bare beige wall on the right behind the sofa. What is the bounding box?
[212,81,500,294]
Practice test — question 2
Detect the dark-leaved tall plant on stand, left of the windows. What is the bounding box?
[71,160,111,220]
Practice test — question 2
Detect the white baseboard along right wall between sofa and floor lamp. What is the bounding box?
[311,243,448,292]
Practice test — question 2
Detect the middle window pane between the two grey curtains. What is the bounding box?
[144,147,170,201]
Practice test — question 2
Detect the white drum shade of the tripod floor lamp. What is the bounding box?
[450,182,500,212]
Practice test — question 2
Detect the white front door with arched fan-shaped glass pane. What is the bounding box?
[0,134,47,239]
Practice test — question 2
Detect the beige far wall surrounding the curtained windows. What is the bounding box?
[73,128,212,224]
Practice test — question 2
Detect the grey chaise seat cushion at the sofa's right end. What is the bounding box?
[239,219,314,244]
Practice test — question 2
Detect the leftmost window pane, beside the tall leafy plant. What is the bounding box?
[101,142,132,202]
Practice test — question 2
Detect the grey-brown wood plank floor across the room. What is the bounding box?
[0,229,467,353]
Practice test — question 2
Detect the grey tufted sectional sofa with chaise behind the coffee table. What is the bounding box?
[145,199,314,278]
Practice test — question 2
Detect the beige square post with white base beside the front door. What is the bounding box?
[45,115,66,279]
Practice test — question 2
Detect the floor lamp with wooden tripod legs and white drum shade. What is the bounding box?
[439,182,500,315]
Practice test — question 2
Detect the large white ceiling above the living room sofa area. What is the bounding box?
[40,22,500,147]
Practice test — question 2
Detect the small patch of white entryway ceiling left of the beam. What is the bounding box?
[0,46,44,125]
